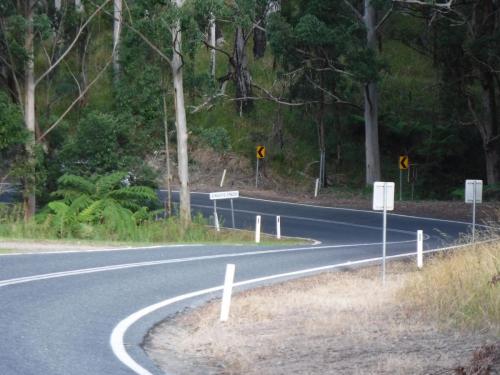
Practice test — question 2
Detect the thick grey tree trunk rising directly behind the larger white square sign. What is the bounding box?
[363,0,380,185]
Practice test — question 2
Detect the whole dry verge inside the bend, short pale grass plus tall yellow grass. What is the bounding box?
[145,245,500,374]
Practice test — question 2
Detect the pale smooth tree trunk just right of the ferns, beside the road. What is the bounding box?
[172,13,191,229]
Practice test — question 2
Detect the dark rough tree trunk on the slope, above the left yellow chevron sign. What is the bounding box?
[233,26,252,115]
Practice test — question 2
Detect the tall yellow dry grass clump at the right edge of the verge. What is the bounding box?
[399,243,500,336]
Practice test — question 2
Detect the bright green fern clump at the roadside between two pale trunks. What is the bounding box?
[37,172,159,238]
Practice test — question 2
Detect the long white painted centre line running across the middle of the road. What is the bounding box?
[0,239,416,287]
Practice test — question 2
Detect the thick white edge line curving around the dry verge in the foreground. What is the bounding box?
[109,239,498,375]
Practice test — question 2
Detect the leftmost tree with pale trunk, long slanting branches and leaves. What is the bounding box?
[0,0,110,220]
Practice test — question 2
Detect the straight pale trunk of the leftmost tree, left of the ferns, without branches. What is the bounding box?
[24,0,36,221]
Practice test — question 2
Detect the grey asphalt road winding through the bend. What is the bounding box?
[0,194,469,375]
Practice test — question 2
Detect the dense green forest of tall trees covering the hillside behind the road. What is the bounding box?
[0,0,500,223]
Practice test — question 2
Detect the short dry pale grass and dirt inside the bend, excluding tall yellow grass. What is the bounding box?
[145,265,500,375]
